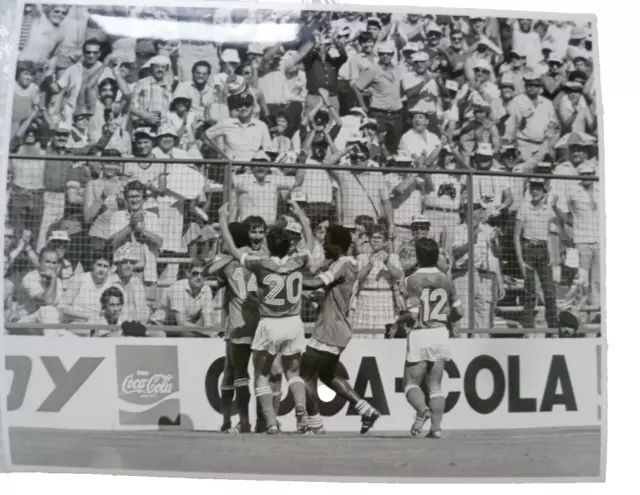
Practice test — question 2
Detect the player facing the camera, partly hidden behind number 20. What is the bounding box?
[207,223,258,433]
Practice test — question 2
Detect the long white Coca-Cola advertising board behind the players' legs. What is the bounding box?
[4,336,604,432]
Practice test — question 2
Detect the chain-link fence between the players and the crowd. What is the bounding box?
[4,156,602,336]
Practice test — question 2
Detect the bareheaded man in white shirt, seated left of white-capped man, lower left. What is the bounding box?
[59,248,114,323]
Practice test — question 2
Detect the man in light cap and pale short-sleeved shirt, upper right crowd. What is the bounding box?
[505,71,559,160]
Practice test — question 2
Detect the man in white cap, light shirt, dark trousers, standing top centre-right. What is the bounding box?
[354,42,403,153]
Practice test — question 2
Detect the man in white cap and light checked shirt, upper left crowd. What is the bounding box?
[131,55,172,129]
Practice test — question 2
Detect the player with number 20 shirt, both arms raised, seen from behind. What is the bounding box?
[220,202,313,434]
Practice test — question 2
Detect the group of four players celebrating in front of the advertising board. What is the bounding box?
[207,201,463,438]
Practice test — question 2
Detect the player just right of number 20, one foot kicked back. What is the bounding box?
[301,225,380,435]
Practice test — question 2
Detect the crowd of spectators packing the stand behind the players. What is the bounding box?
[4,4,600,335]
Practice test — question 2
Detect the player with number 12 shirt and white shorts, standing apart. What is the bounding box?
[397,238,463,438]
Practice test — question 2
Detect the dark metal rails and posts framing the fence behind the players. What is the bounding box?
[5,153,600,334]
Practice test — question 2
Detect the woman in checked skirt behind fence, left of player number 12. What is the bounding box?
[352,225,403,332]
